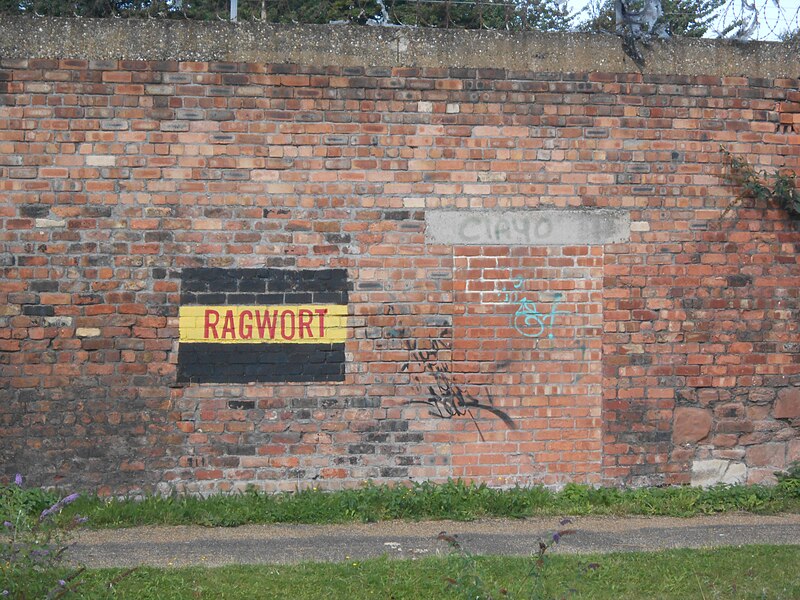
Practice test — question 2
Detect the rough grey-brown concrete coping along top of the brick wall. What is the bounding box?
[0,17,800,78]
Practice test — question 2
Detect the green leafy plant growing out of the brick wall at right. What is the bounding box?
[721,148,800,219]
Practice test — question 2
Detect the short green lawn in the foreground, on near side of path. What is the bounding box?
[15,546,800,600]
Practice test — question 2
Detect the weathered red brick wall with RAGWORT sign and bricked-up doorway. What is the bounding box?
[0,21,800,493]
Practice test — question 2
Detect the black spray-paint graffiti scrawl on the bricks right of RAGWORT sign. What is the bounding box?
[400,340,516,441]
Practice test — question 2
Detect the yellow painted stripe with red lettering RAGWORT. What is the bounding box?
[179,304,347,344]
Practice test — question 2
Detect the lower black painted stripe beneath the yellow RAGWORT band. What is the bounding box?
[178,343,344,383]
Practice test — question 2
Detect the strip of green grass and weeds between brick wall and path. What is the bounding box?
[47,477,800,528]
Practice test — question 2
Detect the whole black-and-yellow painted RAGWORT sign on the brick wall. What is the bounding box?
[178,268,349,383]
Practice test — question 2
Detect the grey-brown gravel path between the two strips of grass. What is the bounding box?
[69,514,800,567]
